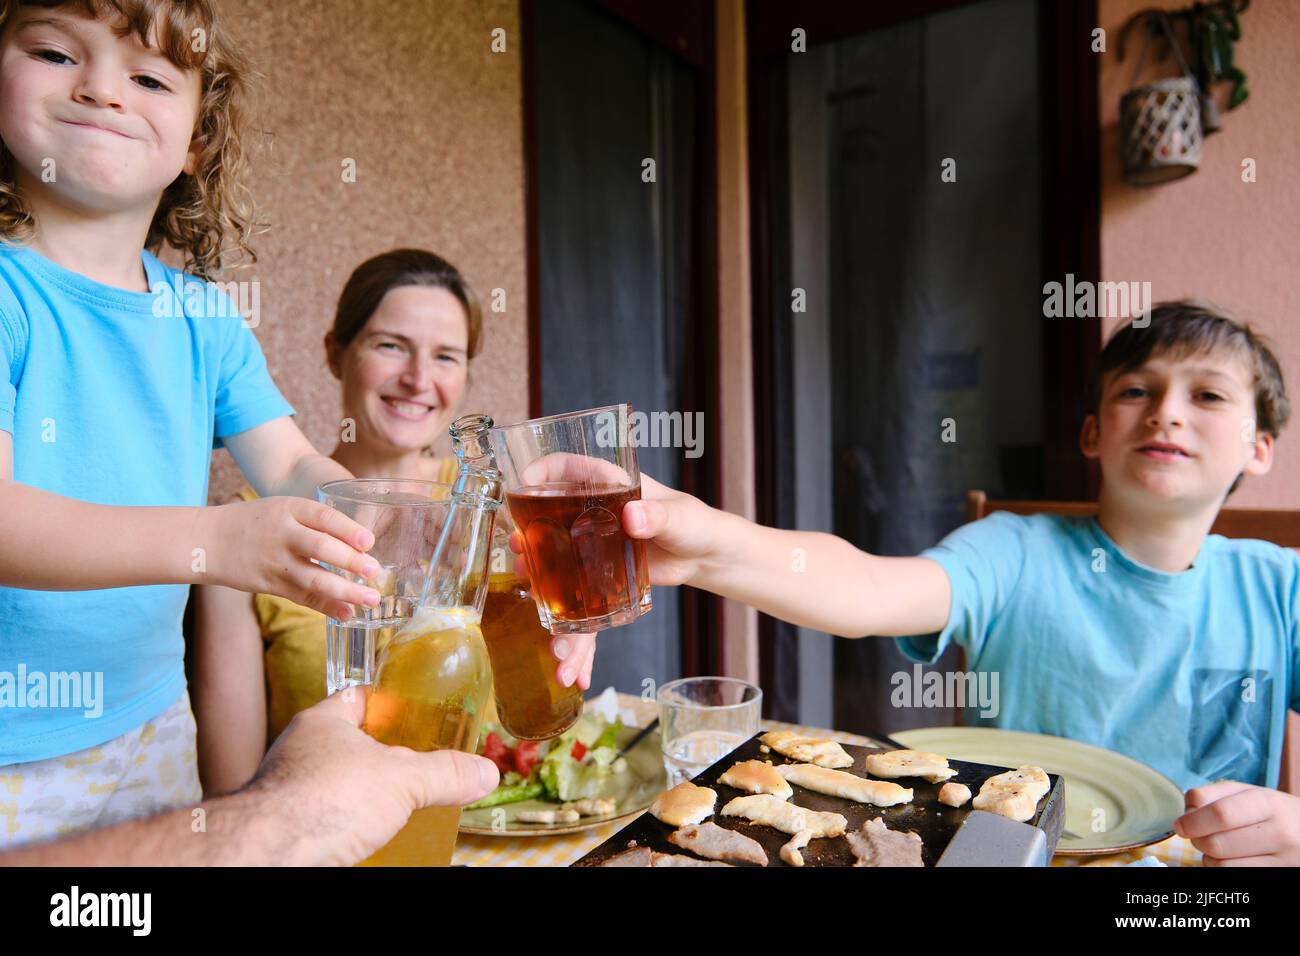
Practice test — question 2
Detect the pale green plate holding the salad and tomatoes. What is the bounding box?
[460,727,668,836]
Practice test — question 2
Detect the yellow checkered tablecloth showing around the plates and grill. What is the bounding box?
[451,693,1201,866]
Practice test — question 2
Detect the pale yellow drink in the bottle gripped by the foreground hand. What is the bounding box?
[361,607,491,866]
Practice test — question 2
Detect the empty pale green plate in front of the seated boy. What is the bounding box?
[893,727,1183,856]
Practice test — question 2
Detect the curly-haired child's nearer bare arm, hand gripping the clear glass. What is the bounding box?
[0,431,378,618]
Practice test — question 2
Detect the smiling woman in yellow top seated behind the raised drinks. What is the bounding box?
[194,248,482,793]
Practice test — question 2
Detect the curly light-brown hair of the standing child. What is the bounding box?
[0,0,257,278]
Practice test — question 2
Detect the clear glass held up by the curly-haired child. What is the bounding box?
[316,479,451,695]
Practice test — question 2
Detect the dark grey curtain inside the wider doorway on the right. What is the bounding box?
[769,0,1043,732]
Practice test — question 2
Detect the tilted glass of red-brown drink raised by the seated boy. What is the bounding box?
[491,405,650,635]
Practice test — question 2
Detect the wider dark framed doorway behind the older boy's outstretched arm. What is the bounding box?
[750,0,1097,732]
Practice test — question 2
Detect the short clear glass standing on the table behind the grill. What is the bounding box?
[658,678,763,787]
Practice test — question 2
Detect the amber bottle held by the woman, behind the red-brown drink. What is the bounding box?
[482,509,582,740]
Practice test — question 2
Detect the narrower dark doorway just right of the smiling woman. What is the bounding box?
[523,0,718,693]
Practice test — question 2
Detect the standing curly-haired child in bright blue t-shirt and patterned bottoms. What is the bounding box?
[0,0,378,847]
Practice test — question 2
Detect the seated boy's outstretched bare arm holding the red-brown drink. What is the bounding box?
[623,475,952,637]
